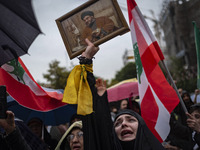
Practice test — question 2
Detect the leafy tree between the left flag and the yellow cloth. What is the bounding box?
[43,60,70,89]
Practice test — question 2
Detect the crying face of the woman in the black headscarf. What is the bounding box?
[114,114,138,141]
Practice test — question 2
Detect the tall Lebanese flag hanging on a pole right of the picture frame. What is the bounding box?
[127,0,179,142]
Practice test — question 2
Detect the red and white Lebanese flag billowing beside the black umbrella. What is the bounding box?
[0,58,66,111]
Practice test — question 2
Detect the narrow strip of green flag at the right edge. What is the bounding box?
[193,22,200,89]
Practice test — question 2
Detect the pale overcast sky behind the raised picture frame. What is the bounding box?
[21,0,163,83]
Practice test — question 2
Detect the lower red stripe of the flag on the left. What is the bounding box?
[0,68,66,111]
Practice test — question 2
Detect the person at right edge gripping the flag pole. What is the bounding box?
[187,104,200,150]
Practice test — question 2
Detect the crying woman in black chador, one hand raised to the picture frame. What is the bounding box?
[63,40,164,150]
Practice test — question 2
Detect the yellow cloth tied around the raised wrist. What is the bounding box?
[62,64,93,115]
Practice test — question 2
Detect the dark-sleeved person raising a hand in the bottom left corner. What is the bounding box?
[0,111,31,150]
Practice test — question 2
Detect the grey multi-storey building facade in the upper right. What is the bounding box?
[159,0,200,71]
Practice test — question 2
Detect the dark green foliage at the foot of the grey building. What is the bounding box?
[170,58,197,92]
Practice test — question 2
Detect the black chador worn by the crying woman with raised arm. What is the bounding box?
[82,72,164,150]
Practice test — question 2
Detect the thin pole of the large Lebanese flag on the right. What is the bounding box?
[161,60,188,113]
